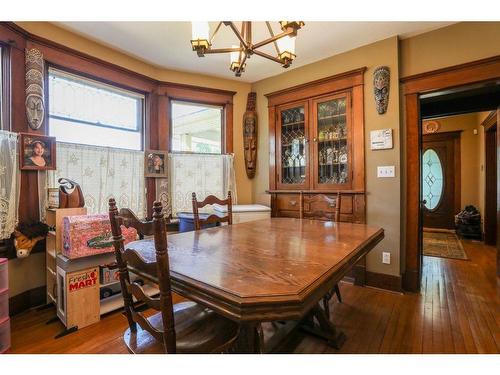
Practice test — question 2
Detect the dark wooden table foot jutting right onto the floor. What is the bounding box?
[300,304,346,350]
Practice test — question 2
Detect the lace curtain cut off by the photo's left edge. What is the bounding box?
[0,130,21,239]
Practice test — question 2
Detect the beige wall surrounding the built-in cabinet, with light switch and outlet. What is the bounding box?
[252,37,400,275]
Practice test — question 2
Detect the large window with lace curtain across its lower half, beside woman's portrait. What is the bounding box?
[48,69,146,217]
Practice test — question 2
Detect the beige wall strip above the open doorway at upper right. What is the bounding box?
[400,22,500,77]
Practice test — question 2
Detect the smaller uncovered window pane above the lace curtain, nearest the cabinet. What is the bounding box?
[172,101,224,154]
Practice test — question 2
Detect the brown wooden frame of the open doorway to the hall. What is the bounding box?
[400,55,500,292]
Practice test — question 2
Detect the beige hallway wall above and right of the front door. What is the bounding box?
[424,113,484,212]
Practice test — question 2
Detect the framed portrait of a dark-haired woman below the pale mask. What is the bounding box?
[19,133,56,171]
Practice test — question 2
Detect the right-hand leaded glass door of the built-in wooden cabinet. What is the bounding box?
[313,93,352,189]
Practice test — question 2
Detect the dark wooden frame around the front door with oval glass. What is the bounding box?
[422,130,462,231]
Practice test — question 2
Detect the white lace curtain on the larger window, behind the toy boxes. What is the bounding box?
[48,142,146,218]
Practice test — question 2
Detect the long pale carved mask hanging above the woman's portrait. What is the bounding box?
[25,48,45,130]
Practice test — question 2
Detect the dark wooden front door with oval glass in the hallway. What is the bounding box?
[421,132,460,229]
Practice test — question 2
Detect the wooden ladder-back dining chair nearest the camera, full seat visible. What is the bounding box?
[109,199,238,354]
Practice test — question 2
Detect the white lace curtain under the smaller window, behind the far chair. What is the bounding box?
[169,154,237,216]
